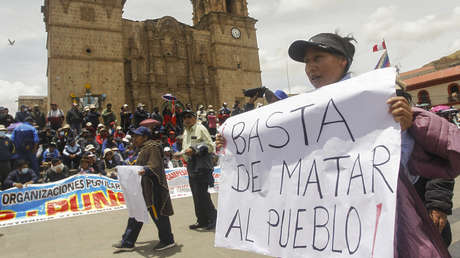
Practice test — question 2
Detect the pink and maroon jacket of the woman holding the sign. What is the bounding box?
[394,108,460,258]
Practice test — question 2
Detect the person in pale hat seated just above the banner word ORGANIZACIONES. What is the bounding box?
[4,160,38,188]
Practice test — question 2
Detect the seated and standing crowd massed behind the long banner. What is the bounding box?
[0,98,266,190]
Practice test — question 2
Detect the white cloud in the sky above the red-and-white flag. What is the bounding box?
[364,5,460,42]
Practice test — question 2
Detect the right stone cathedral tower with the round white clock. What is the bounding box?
[191,0,262,106]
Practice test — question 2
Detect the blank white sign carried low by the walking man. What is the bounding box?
[117,166,151,223]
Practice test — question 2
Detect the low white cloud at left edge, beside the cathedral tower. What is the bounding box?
[0,80,47,116]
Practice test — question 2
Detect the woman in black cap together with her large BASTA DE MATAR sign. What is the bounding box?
[216,33,460,257]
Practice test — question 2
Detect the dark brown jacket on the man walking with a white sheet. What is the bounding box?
[136,140,174,216]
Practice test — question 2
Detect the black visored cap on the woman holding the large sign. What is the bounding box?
[289,33,355,70]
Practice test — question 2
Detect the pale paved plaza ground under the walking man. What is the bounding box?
[0,180,460,258]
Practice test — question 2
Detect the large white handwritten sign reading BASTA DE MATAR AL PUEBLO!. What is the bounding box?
[215,68,401,258]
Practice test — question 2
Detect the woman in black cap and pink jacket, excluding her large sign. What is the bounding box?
[216,33,460,257]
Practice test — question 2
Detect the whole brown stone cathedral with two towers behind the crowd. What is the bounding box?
[42,0,261,111]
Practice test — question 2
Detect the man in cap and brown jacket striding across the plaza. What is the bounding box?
[113,126,176,251]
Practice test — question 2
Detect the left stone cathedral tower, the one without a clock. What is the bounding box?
[42,0,126,111]
